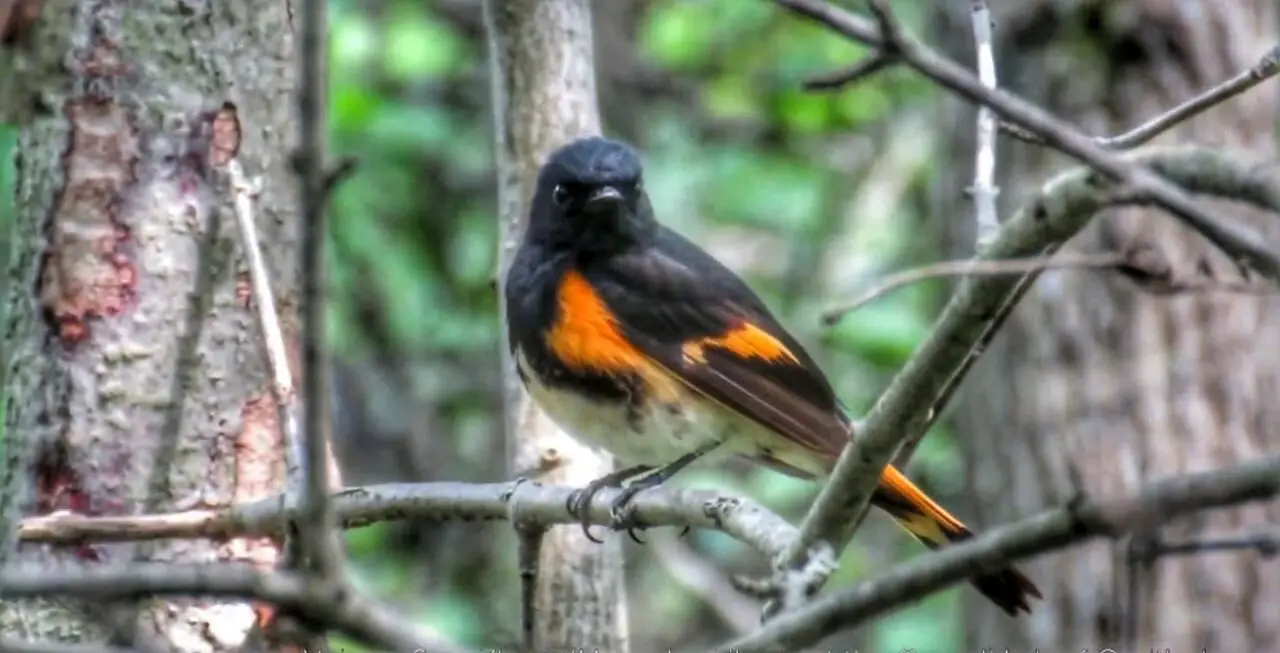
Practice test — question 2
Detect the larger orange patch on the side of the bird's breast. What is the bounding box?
[547,270,677,399]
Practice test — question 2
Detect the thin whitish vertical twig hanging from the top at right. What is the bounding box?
[969,0,1000,251]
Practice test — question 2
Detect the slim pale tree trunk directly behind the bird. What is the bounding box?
[485,0,627,650]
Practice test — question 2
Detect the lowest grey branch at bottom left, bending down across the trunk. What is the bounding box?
[0,562,458,650]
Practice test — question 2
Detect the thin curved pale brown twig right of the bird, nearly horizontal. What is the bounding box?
[822,252,1125,321]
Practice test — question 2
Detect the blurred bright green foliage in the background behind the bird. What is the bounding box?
[0,0,960,652]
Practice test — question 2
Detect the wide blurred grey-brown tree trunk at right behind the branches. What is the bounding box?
[934,0,1280,650]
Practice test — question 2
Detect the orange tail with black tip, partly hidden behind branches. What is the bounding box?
[872,466,1042,617]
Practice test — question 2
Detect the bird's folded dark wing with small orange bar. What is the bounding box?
[589,230,849,458]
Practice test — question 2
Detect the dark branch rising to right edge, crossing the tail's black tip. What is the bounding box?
[714,457,1280,652]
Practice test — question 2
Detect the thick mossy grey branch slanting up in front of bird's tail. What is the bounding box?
[762,149,1280,604]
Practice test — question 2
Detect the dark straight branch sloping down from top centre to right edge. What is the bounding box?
[773,0,1280,280]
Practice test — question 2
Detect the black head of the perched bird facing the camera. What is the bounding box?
[529,136,657,255]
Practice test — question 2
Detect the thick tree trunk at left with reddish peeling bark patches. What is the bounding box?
[0,0,297,652]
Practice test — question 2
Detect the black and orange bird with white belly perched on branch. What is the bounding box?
[504,137,1041,616]
